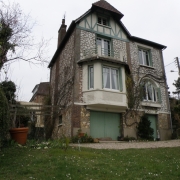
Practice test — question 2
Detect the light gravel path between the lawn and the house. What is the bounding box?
[70,140,180,149]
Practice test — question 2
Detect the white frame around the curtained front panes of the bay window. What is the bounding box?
[102,66,120,91]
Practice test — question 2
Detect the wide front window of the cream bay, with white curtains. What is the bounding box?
[103,67,119,90]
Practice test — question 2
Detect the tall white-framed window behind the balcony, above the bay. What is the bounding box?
[96,38,110,56]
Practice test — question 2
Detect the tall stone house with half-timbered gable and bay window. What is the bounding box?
[48,0,171,140]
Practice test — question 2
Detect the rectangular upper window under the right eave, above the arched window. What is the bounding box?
[139,49,152,66]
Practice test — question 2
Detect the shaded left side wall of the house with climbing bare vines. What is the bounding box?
[51,32,75,138]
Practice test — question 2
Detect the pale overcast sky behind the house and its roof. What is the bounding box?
[0,0,180,101]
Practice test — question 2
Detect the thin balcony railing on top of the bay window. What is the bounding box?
[83,47,123,61]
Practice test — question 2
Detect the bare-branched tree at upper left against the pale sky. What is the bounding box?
[0,0,48,69]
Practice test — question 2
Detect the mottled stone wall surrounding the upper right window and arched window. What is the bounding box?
[130,42,168,112]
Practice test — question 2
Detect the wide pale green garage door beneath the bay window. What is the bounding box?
[90,111,120,140]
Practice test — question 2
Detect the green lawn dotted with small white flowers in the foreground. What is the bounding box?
[0,143,180,180]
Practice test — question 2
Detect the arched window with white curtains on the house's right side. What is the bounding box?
[142,80,161,102]
